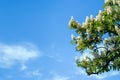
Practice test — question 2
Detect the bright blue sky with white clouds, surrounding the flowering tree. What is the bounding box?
[0,0,120,80]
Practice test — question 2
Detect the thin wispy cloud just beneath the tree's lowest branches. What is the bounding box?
[76,68,119,80]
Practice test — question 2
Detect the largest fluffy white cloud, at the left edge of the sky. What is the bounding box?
[0,43,40,69]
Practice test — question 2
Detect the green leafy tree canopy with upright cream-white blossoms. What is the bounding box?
[69,0,120,75]
